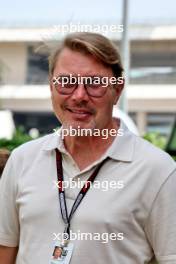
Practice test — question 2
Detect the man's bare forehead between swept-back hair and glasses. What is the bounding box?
[54,48,112,76]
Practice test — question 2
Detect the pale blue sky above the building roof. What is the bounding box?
[0,0,176,26]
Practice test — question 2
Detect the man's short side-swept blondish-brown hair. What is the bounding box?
[49,32,123,77]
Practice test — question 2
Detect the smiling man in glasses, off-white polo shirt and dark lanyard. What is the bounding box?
[0,33,176,264]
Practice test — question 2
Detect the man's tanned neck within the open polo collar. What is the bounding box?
[64,120,119,169]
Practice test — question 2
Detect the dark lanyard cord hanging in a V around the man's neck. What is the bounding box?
[55,149,109,236]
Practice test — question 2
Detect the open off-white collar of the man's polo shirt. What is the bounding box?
[43,120,136,162]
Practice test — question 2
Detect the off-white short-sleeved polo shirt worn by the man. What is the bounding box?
[0,122,176,264]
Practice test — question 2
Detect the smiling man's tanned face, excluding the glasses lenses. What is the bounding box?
[50,48,121,129]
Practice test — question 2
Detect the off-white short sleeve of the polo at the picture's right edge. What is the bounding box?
[146,170,176,264]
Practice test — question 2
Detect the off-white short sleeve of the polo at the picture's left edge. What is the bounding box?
[0,154,19,247]
